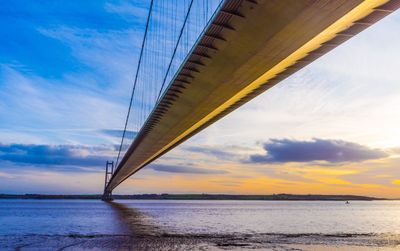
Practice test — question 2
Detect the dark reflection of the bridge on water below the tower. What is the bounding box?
[106,201,162,236]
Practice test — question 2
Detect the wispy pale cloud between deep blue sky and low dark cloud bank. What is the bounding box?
[0,65,126,144]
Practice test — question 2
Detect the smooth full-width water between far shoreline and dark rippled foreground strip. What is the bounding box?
[0,200,400,235]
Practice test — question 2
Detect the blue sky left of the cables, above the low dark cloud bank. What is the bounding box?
[0,1,145,143]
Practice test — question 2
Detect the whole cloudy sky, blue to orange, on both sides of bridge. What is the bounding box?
[0,0,400,198]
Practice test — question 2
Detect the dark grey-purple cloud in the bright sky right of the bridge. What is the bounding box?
[250,139,387,163]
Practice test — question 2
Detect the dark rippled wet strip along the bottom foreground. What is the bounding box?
[0,234,400,251]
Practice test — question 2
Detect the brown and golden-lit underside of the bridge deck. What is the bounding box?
[107,0,400,191]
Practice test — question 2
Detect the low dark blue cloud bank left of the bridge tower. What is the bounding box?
[0,144,112,168]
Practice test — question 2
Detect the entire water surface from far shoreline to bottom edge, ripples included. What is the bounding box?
[0,200,400,250]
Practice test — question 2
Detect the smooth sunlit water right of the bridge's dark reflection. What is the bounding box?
[112,200,400,235]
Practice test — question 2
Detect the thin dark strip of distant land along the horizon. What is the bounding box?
[0,194,394,201]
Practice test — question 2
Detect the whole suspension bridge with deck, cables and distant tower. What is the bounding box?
[103,0,400,200]
